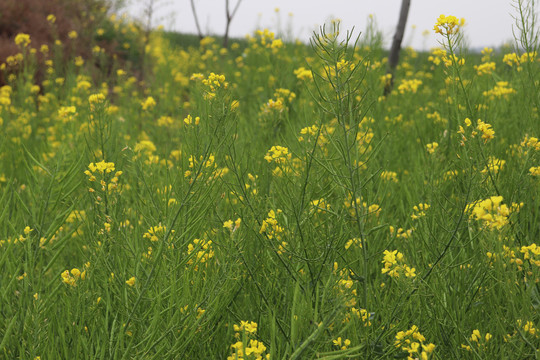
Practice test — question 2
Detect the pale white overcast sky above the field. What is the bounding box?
[127,0,538,50]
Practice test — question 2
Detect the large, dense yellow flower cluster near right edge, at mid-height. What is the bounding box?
[465,196,522,230]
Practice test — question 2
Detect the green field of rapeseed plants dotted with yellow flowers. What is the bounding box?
[0,3,540,360]
